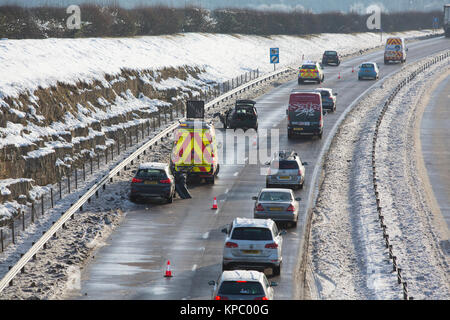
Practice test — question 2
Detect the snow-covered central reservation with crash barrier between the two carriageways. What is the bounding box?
[310,50,450,300]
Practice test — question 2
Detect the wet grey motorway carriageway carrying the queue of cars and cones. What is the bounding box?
[72,38,450,300]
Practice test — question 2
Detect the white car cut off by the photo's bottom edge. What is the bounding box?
[208,270,277,300]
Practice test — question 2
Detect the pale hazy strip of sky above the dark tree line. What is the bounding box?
[0,0,448,13]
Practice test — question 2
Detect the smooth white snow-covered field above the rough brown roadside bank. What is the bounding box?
[0,30,431,99]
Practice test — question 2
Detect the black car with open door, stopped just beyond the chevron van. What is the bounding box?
[214,100,258,131]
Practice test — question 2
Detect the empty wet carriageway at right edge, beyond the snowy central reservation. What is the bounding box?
[420,72,450,228]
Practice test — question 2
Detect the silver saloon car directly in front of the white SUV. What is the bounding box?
[252,188,300,227]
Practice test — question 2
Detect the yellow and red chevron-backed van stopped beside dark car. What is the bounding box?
[171,119,219,183]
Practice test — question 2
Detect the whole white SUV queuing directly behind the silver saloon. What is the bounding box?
[222,218,286,275]
